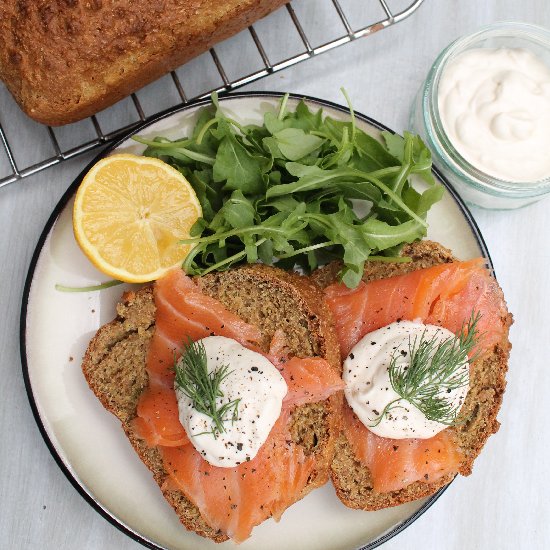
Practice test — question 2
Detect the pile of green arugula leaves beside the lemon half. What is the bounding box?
[135,91,443,287]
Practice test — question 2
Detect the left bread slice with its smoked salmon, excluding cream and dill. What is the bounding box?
[82,265,343,542]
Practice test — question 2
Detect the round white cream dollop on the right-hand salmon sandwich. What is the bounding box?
[343,321,469,439]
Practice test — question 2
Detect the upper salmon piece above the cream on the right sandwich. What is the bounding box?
[325,258,506,358]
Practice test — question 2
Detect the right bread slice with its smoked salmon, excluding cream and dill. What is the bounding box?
[313,241,512,510]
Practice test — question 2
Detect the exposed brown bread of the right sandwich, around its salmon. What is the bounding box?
[312,241,512,510]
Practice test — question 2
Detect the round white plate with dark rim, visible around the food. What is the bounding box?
[21,93,488,550]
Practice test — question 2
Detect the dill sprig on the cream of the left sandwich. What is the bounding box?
[175,340,241,438]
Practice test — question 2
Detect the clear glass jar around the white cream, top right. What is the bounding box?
[410,22,550,209]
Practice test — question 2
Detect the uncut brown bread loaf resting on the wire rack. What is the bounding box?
[0,0,288,125]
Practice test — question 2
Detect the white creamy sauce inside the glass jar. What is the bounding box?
[438,48,550,182]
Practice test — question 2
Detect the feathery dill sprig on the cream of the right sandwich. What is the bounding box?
[371,312,481,427]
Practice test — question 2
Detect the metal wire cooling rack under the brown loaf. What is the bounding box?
[0,0,423,187]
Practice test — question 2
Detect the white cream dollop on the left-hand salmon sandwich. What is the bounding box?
[175,336,288,468]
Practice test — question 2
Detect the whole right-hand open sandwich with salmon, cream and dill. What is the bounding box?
[314,241,512,510]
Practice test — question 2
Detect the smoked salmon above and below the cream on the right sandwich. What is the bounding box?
[325,258,508,492]
